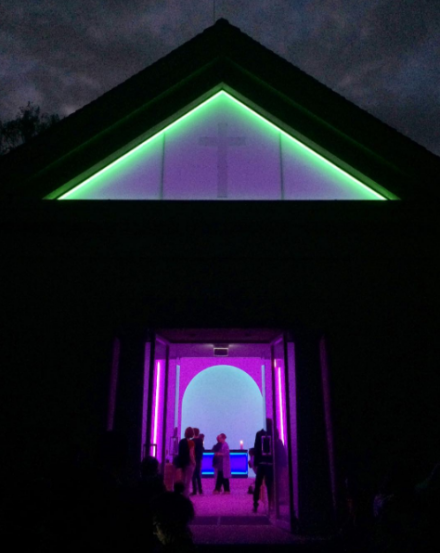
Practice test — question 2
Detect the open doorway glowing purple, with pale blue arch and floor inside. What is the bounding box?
[142,329,297,530]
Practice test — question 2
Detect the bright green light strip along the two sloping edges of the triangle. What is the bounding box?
[58,90,386,200]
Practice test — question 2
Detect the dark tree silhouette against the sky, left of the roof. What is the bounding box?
[0,102,60,155]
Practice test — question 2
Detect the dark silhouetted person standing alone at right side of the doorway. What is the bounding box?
[253,419,273,513]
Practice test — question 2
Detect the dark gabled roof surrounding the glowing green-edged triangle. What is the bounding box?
[0,19,440,199]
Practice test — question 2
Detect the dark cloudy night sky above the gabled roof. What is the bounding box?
[0,0,440,155]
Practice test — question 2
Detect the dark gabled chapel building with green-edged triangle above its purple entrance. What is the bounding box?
[0,20,440,528]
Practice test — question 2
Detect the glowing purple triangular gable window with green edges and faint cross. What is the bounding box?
[58,90,385,200]
